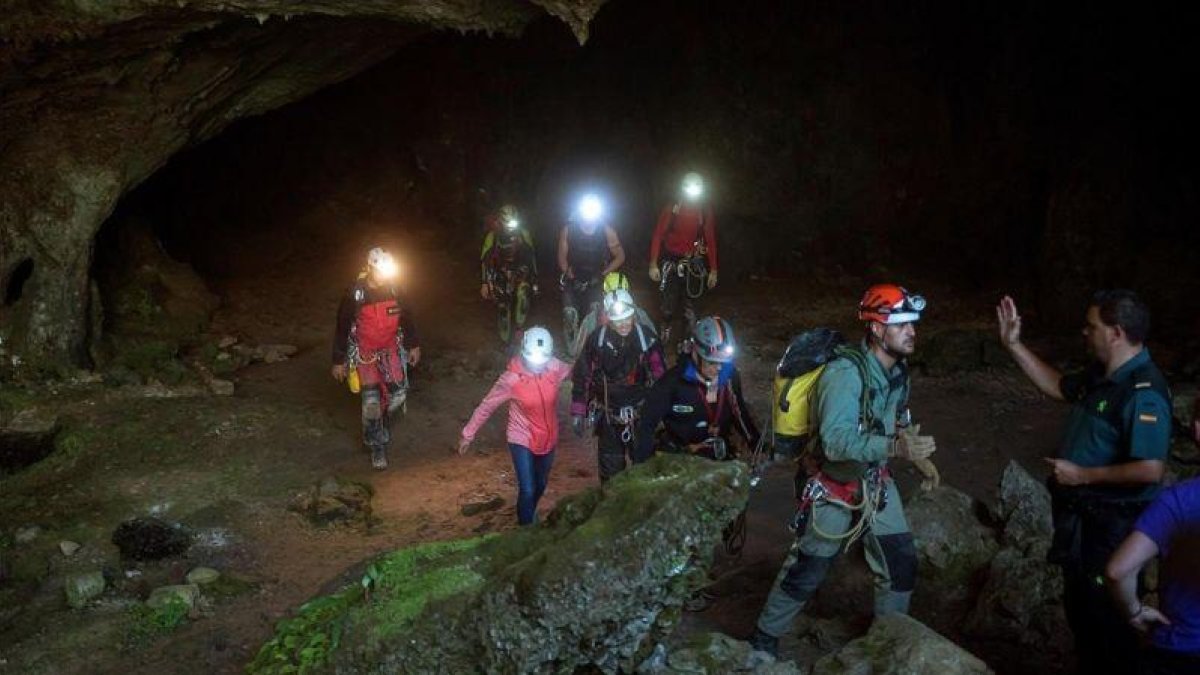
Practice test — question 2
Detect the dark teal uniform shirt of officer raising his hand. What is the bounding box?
[1058,348,1171,500]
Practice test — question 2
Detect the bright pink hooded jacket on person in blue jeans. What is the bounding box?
[462,357,571,455]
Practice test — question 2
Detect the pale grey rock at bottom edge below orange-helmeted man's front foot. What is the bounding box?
[812,614,992,675]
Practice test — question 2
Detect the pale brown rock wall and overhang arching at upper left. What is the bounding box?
[0,0,602,363]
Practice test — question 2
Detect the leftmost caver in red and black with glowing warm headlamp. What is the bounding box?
[331,247,421,470]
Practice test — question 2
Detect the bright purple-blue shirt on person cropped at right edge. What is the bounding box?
[1134,478,1200,655]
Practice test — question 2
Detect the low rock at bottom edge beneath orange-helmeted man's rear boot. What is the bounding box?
[637,633,802,675]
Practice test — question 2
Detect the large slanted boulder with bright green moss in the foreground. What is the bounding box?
[248,455,749,674]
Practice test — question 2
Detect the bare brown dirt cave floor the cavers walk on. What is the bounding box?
[0,227,1080,674]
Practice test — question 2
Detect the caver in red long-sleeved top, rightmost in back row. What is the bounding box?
[650,172,716,344]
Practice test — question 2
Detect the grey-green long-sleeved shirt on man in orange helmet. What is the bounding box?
[816,341,908,479]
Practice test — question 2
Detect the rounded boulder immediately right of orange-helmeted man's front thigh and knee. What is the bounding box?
[905,485,1000,595]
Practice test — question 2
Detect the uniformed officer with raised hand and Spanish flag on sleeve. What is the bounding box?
[996,289,1171,674]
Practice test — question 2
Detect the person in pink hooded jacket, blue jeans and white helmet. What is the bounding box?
[458,325,571,525]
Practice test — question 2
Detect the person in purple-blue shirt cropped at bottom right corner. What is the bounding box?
[1105,470,1200,675]
